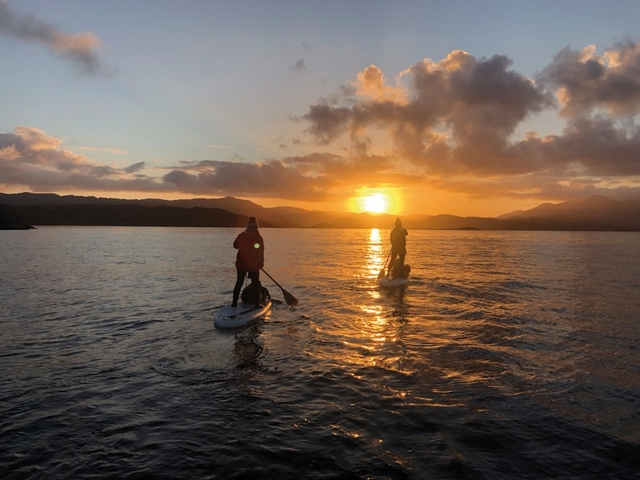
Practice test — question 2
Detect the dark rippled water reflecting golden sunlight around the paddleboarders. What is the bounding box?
[0,227,640,479]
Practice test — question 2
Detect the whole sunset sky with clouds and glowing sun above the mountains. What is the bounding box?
[0,0,640,216]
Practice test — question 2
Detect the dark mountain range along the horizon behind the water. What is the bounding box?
[0,193,640,231]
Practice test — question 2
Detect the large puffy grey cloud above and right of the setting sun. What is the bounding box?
[302,51,550,170]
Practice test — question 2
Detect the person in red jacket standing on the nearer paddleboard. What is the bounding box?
[231,217,264,308]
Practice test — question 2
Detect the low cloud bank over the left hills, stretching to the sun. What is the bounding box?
[0,126,410,201]
